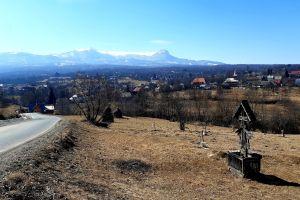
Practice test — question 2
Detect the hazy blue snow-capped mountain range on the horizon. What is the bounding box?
[0,49,223,66]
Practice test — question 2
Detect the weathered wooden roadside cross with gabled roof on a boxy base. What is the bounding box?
[228,100,262,177]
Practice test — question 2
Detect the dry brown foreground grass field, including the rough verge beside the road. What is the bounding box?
[0,116,300,200]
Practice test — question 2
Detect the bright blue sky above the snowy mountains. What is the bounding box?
[0,0,300,64]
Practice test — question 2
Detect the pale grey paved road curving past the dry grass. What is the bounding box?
[0,113,60,153]
